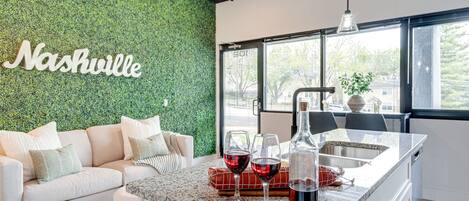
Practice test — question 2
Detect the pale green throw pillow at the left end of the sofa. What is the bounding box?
[29,144,82,183]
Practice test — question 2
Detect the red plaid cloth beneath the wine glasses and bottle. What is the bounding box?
[208,166,338,191]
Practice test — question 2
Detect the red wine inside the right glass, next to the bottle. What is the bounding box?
[251,158,280,182]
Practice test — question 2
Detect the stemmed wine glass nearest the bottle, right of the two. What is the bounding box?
[251,134,281,201]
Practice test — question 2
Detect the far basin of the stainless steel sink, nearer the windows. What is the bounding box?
[319,141,388,159]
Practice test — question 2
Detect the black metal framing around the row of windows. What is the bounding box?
[220,7,469,120]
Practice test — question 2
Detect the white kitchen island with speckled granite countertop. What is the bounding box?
[126,129,426,201]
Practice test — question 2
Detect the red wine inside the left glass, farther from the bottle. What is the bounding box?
[223,150,251,174]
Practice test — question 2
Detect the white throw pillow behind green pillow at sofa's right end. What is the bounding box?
[121,116,161,160]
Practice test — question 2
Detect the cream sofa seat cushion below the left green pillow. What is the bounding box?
[23,167,122,201]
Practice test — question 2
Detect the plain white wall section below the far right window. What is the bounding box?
[410,119,469,201]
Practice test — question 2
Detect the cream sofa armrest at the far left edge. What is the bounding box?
[0,156,23,201]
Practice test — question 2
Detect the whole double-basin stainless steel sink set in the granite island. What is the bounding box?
[319,141,388,168]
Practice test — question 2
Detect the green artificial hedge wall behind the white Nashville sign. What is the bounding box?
[0,0,216,156]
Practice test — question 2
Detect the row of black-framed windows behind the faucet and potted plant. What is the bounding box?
[229,9,469,120]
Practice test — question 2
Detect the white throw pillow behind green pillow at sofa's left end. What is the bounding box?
[0,122,62,182]
